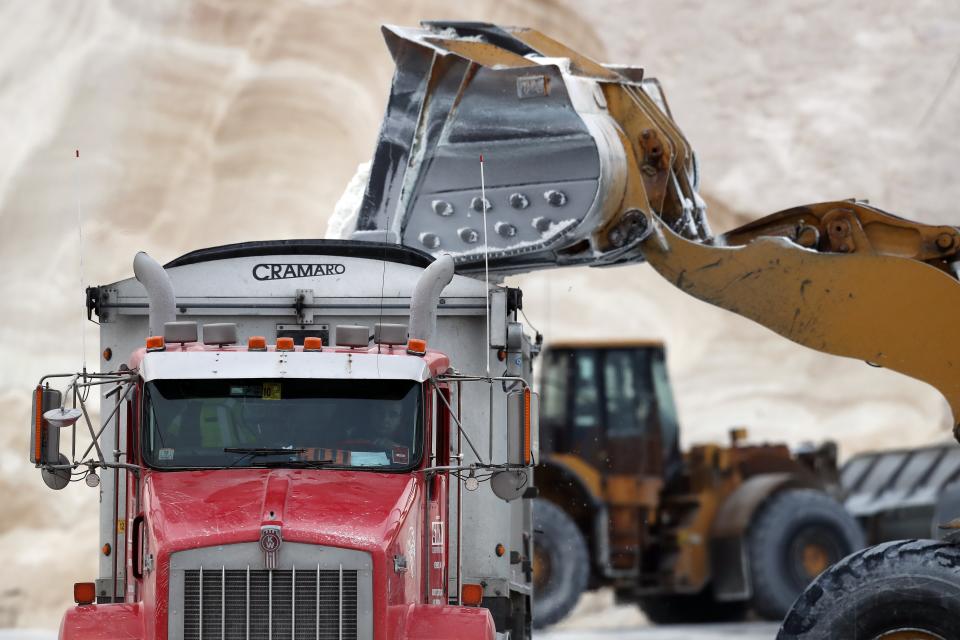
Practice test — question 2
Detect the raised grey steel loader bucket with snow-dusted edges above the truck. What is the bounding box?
[341,22,703,273]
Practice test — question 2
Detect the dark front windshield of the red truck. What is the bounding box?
[143,379,423,470]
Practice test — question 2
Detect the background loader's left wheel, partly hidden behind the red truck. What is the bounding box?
[533,498,590,629]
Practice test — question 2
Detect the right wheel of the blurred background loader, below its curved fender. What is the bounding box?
[748,489,866,620]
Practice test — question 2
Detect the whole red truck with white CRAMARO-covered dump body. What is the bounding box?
[35,242,536,640]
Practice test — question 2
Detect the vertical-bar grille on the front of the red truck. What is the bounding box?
[183,566,358,640]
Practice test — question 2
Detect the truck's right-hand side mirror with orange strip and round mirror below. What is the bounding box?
[490,388,540,502]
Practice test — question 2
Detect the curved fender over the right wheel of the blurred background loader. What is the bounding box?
[710,473,823,601]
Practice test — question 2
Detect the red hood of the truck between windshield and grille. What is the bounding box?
[143,469,420,553]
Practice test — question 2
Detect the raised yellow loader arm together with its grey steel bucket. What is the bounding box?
[348,22,960,436]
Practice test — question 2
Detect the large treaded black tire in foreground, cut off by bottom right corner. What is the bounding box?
[777,540,960,640]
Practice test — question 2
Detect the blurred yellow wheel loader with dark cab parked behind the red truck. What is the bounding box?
[533,341,865,626]
